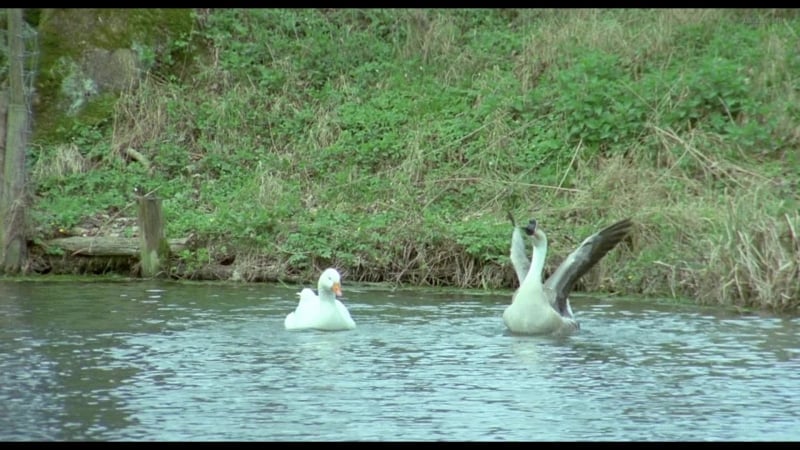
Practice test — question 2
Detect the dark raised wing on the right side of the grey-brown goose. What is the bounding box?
[544,219,633,315]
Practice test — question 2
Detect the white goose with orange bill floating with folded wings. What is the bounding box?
[283,268,356,331]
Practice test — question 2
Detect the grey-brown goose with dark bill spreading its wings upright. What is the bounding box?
[503,213,633,336]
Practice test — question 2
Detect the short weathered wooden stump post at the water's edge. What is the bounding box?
[137,191,169,278]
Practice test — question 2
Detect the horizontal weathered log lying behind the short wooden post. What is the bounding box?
[42,236,192,257]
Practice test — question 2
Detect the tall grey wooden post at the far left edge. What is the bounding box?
[0,8,28,273]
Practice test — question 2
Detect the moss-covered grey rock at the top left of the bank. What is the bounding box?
[34,9,194,142]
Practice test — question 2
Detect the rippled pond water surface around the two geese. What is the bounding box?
[0,282,800,441]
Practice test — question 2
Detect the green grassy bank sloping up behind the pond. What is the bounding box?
[25,10,800,311]
